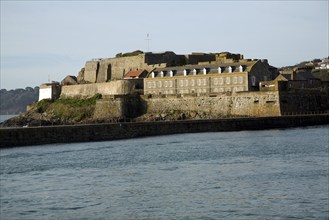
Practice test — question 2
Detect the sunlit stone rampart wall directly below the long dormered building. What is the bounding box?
[143,92,281,118]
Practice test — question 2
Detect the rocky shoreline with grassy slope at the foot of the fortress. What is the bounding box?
[0,96,237,128]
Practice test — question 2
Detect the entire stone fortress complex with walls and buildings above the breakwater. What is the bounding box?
[39,51,329,121]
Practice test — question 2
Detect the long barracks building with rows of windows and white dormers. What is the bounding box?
[144,60,273,94]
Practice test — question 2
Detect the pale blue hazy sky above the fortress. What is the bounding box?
[0,0,329,90]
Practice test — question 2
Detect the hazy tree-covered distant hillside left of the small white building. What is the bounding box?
[0,87,39,115]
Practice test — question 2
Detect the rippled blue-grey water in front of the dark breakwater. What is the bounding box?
[0,126,329,219]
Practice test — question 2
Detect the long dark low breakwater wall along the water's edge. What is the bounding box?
[0,114,329,148]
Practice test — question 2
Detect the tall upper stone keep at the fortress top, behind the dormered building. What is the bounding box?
[78,51,243,83]
